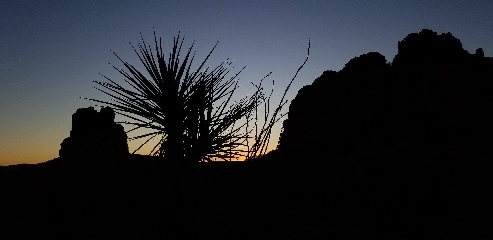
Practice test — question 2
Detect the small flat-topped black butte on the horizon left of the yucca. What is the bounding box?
[59,107,129,158]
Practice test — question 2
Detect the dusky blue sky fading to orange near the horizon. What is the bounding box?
[0,0,493,165]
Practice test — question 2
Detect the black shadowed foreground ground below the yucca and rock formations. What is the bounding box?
[0,153,491,239]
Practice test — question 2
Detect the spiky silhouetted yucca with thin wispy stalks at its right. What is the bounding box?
[89,33,308,162]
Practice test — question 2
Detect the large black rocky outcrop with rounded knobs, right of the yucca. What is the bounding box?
[278,30,493,165]
